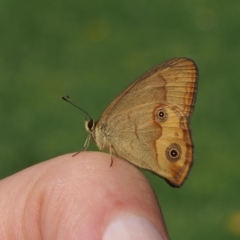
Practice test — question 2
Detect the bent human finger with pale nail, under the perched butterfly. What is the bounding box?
[0,152,169,240]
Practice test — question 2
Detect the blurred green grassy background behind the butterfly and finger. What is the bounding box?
[0,0,240,240]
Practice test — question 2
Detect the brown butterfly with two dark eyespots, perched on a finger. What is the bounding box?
[62,58,198,186]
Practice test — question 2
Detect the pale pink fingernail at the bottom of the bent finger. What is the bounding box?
[103,215,165,240]
